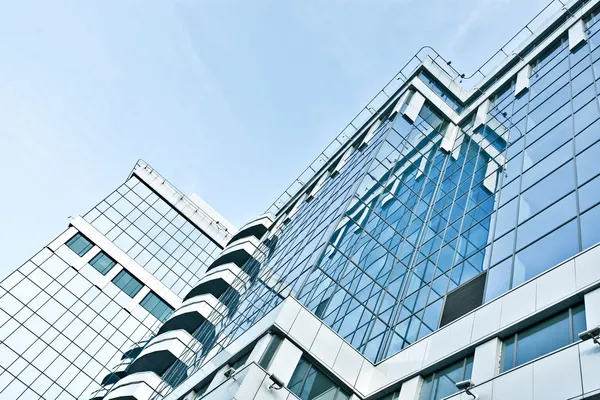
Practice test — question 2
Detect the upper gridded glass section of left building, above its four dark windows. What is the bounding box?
[84,176,221,297]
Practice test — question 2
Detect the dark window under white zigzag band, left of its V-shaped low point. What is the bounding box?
[288,357,350,400]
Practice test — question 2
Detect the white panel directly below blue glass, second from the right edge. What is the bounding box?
[536,260,575,310]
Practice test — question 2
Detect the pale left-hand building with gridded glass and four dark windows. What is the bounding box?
[0,162,235,400]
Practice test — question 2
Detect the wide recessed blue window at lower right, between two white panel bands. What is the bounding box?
[502,304,586,371]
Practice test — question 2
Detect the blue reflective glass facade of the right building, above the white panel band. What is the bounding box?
[158,9,600,394]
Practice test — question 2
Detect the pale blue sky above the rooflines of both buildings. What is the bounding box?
[0,0,547,278]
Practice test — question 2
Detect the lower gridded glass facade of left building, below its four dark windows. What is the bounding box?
[0,241,158,400]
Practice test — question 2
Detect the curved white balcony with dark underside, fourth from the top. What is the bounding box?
[158,294,227,335]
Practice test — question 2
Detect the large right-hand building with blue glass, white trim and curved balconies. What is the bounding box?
[5,0,600,400]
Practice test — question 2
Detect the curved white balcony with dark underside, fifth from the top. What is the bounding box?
[128,329,198,375]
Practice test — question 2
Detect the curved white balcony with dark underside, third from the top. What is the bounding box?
[183,263,250,301]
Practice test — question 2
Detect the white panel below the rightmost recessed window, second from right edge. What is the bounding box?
[533,346,582,400]
